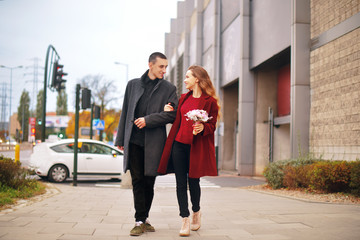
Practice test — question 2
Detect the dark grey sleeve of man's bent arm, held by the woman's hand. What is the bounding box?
[145,87,178,128]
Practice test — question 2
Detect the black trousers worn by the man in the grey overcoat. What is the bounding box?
[129,143,156,223]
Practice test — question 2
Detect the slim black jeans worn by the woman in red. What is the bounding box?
[172,141,201,217]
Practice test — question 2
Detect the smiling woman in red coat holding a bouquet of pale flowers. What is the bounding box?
[158,66,220,236]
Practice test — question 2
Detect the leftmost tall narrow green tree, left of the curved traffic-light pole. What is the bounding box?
[17,89,30,141]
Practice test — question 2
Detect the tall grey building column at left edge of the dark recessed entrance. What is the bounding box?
[236,0,255,176]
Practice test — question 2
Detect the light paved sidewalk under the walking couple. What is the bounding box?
[0,179,360,240]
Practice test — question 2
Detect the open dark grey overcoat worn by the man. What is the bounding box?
[115,70,178,176]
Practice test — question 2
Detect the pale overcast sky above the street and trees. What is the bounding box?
[0,0,178,119]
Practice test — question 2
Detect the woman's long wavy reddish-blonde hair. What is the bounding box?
[188,65,221,120]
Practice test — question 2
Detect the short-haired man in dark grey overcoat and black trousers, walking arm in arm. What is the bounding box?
[115,52,178,236]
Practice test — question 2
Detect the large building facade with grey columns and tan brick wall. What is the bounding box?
[165,0,360,176]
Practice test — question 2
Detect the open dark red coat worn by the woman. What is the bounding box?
[158,92,218,178]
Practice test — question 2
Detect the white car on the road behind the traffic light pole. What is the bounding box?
[30,139,123,182]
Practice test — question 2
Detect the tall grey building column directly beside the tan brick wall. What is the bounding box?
[290,0,310,158]
